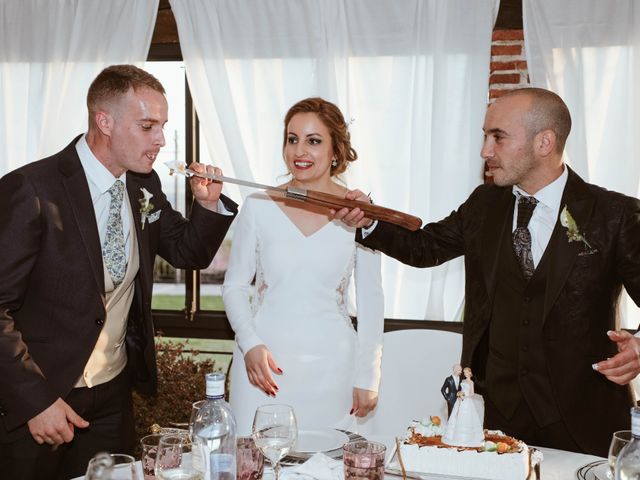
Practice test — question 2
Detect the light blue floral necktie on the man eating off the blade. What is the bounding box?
[102,180,127,286]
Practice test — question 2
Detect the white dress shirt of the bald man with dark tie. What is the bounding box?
[511,168,569,267]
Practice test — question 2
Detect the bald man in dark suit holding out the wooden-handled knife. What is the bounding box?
[336,88,640,456]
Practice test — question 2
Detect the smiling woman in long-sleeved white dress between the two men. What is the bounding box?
[223,98,384,435]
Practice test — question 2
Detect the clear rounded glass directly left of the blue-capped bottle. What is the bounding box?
[155,433,204,480]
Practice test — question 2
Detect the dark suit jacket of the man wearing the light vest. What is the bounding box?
[0,139,237,441]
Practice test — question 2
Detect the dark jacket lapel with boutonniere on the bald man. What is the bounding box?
[543,167,594,322]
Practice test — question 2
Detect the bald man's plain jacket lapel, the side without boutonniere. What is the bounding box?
[481,188,515,302]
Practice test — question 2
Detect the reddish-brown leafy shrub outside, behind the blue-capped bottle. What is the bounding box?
[133,337,215,455]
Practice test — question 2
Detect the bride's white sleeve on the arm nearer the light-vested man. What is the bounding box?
[222,197,264,354]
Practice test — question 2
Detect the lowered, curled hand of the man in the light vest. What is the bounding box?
[27,398,89,445]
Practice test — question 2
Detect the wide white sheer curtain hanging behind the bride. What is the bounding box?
[170,0,498,320]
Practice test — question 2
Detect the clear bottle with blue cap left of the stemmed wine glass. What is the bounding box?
[193,372,236,480]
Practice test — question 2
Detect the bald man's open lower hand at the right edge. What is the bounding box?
[592,330,640,385]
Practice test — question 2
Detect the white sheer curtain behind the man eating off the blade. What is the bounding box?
[0,0,159,175]
